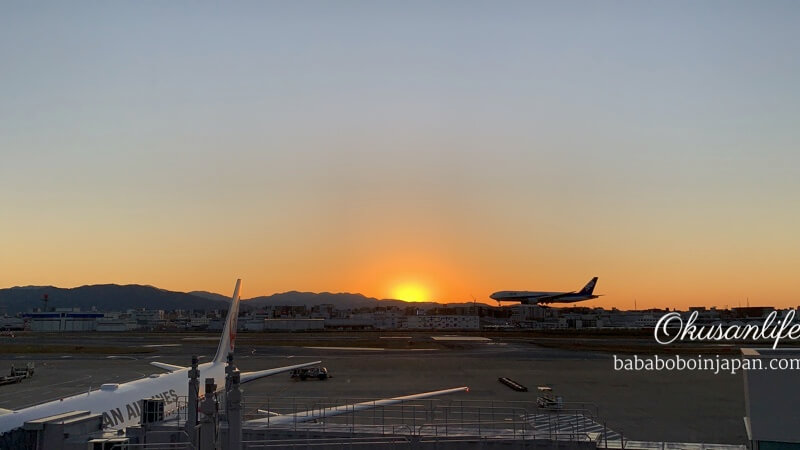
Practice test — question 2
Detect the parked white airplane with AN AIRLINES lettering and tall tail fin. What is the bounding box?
[0,280,321,434]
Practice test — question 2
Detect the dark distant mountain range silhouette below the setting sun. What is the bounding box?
[0,284,456,314]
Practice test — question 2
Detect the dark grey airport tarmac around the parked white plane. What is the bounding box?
[0,333,747,444]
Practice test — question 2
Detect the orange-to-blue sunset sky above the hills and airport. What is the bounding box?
[0,1,800,308]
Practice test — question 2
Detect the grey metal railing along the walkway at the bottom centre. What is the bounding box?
[236,396,607,441]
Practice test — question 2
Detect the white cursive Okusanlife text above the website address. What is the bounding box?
[653,309,800,350]
